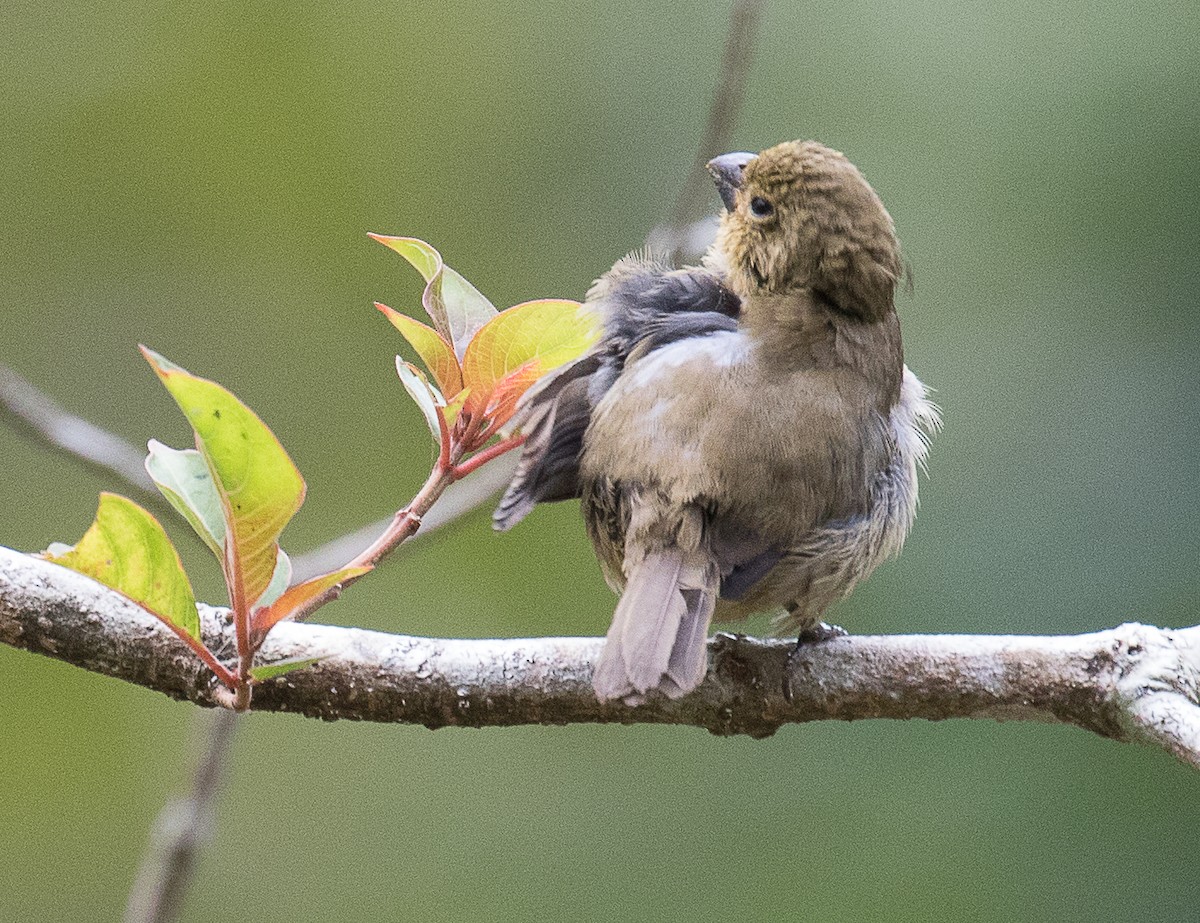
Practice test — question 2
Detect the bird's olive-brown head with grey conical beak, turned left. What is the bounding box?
[708,140,904,320]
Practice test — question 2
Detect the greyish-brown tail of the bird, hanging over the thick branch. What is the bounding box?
[592,546,721,705]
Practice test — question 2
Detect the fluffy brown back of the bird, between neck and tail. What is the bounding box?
[581,331,887,541]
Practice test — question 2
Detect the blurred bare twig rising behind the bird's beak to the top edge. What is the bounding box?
[646,0,766,262]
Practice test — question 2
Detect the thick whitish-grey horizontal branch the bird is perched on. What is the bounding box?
[0,549,1200,768]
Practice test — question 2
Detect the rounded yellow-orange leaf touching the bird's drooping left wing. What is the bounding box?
[462,299,600,395]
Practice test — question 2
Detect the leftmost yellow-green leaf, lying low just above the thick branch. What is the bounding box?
[47,493,200,642]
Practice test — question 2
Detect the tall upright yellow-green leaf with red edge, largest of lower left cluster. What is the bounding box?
[142,347,305,611]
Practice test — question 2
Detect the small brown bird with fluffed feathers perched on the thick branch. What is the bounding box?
[493,142,940,703]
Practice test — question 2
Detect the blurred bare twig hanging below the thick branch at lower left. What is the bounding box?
[125,708,238,923]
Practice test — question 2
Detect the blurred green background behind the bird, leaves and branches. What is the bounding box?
[0,0,1200,921]
